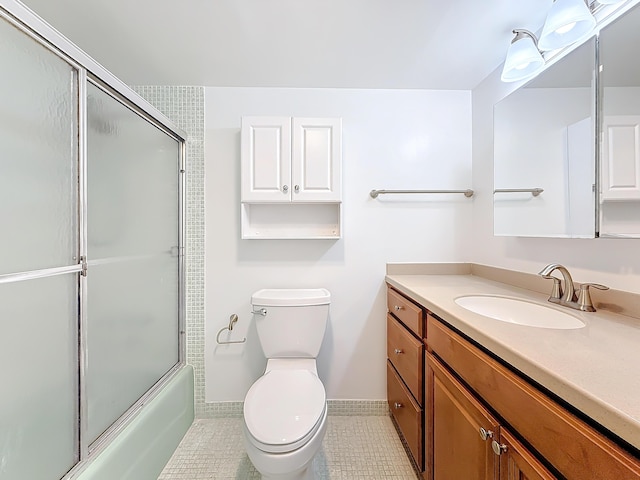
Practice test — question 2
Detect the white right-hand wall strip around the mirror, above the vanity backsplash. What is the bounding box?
[470,70,640,293]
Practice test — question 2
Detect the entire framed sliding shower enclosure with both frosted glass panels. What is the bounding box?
[0,0,185,480]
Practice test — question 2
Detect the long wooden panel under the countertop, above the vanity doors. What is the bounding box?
[427,316,640,480]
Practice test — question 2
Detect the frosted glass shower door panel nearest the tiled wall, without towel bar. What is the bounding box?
[85,83,181,444]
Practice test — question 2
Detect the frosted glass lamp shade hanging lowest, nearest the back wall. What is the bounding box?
[500,30,544,82]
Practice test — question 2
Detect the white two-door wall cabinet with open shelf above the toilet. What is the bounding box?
[240,117,342,239]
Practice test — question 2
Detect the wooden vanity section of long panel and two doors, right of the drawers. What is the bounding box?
[424,315,640,480]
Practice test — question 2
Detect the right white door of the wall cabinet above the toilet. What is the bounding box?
[291,118,342,202]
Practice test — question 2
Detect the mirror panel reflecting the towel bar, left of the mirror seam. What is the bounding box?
[493,38,596,238]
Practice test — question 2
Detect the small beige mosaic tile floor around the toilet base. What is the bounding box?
[158,416,419,480]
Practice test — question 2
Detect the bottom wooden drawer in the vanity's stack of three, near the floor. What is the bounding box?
[387,362,423,471]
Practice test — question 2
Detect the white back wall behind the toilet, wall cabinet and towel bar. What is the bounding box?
[205,88,474,401]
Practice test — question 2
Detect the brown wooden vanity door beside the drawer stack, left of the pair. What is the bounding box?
[425,354,499,480]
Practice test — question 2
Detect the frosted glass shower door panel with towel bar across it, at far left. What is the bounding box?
[0,12,80,480]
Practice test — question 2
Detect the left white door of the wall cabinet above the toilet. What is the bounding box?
[240,117,292,203]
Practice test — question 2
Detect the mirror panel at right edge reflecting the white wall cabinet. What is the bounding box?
[598,1,640,238]
